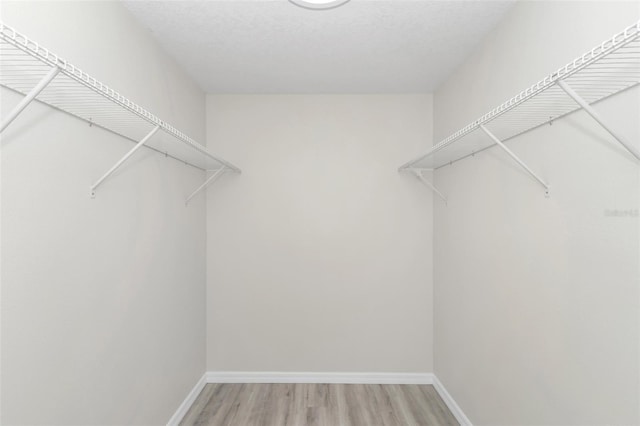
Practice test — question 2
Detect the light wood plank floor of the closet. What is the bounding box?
[181,384,458,426]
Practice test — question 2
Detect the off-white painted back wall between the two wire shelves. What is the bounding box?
[207,95,432,372]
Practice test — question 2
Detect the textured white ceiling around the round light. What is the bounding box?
[124,0,514,93]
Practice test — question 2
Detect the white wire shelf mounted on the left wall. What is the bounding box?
[0,22,240,172]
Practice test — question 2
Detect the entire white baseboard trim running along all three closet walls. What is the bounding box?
[167,371,472,426]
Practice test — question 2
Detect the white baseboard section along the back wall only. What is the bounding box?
[207,371,433,385]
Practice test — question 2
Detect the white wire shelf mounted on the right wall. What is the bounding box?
[400,21,640,170]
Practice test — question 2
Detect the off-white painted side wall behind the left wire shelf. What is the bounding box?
[0,1,206,425]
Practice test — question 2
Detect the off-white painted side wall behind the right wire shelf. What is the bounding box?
[434,1,640,425]
